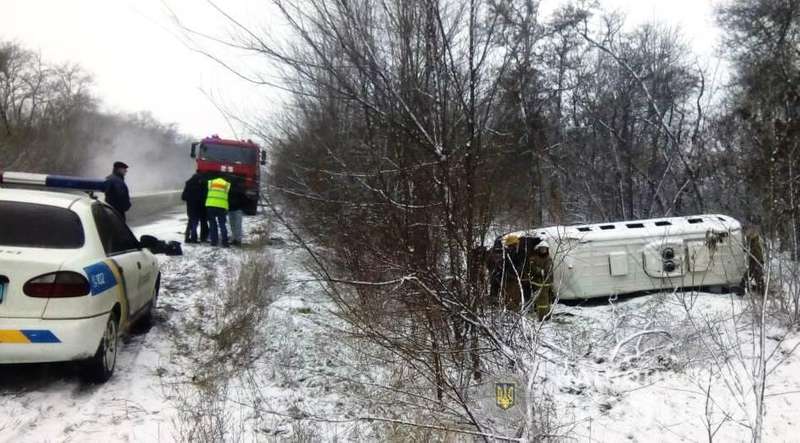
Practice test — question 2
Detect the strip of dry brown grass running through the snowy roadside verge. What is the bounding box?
[167,243,281,442]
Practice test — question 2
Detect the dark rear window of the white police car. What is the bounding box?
[0,201,84,249]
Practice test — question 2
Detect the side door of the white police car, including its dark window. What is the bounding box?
[92,203,148,320]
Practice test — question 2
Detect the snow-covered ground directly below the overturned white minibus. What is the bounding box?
[542,293,800,441]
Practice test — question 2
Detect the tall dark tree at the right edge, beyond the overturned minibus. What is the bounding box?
[717,0,800,258]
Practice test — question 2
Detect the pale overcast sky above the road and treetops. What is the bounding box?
[0,0,718,141]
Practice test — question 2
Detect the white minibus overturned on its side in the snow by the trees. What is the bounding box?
[493,214,747,300]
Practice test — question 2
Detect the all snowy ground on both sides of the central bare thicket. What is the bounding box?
[0,210,800,442]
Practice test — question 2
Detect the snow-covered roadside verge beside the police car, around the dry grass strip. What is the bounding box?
[0,209,356,442]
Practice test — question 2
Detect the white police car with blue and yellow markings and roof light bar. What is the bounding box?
[0,172,160,382]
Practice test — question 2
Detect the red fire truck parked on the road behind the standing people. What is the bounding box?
[191,135,267,215]
